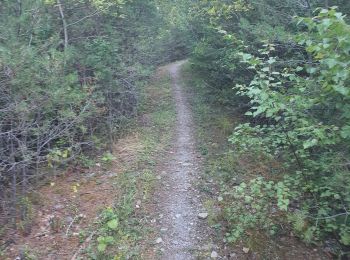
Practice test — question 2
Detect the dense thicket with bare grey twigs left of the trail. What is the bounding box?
[0,0,175,230]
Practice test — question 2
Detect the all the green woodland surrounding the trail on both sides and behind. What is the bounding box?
[0,0,350,255]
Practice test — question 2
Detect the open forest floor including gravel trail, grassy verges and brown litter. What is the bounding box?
[0,61,327,260]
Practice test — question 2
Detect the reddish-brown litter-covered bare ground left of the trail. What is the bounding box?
[0,134,141,260]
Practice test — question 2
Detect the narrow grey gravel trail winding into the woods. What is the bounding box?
[157,61,206,260]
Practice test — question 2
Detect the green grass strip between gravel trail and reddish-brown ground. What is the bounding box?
[86,70,175,260]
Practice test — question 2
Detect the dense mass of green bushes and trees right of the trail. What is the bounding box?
[192,0,350,254]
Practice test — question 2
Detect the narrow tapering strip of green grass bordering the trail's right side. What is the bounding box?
[182,61,249,248]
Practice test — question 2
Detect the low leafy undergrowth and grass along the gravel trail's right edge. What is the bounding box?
[182,63,330,259]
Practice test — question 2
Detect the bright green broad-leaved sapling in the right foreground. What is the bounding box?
[230,9,350,251]
